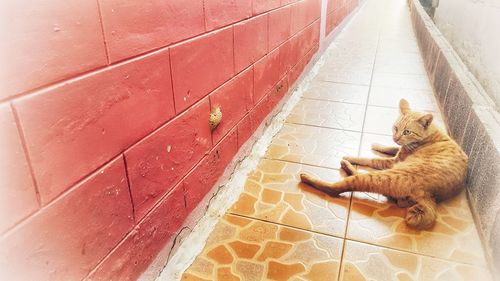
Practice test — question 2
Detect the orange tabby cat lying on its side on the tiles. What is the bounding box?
[300,99,468,229]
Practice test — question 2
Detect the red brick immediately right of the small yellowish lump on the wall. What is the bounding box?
[210,68,253,144]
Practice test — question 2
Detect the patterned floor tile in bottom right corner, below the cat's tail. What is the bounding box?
[340,238,491,281]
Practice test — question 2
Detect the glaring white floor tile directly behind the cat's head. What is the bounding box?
[363,104,446,135]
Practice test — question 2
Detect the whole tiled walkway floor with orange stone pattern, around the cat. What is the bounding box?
[183,0,490,281]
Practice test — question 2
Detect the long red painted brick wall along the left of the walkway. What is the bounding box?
[0,0,357,280]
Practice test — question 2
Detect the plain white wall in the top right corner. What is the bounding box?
[434,0,500,108]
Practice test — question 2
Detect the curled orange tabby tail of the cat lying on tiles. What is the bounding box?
[405,198,437,230]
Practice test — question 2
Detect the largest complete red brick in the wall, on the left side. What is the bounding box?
[14,50,174,203]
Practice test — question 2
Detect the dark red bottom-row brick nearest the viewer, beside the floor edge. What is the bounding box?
[86,184,187,281]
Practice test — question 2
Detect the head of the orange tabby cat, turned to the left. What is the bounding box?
[392,99,433,146]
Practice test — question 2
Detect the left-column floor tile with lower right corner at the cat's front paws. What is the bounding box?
[265,123,361,168]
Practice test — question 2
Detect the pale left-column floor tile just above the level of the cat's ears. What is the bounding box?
[303,80,368,104]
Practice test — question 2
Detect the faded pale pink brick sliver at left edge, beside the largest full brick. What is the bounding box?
[0,104,38,233]
